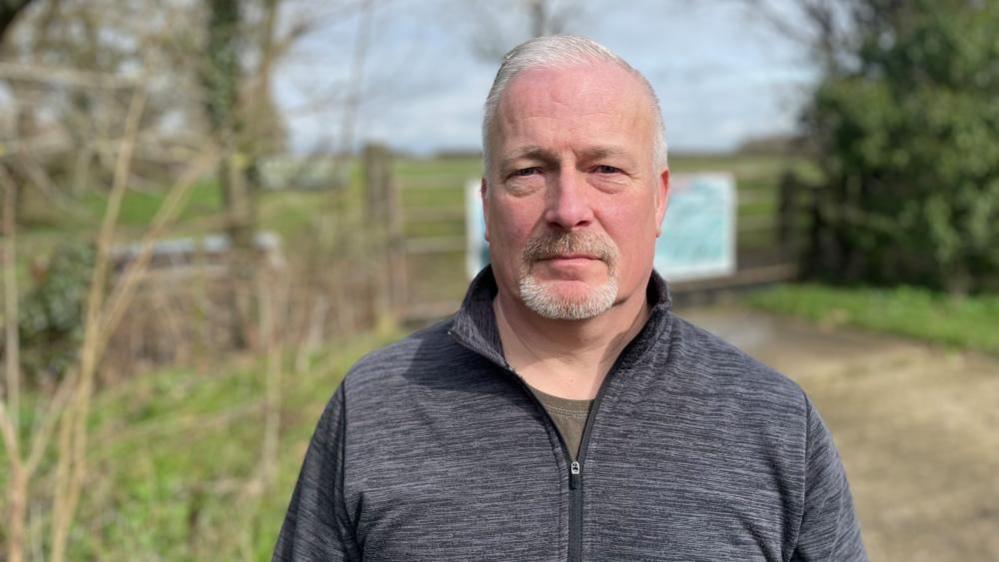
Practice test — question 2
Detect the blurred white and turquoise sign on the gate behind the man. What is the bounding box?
[465,173,736,281]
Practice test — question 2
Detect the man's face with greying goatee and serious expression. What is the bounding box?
[482,63,669,319]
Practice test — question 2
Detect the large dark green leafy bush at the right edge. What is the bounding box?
[808,0,999,293]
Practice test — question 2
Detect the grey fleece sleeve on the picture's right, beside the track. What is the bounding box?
[791,398,867,562]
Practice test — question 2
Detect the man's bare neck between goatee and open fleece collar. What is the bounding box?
[493,284,649,400]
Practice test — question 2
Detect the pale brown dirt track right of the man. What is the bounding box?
[678,307,999,562]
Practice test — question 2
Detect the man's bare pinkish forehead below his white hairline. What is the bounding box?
[491,63,654,156]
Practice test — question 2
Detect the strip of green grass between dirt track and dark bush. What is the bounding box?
[748,284,999,354]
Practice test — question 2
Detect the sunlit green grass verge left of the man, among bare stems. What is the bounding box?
[0,331,399,562]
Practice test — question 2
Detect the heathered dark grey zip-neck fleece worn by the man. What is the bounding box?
[274,268,866,561]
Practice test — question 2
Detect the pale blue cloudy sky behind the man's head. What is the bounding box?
[275,0,817,155]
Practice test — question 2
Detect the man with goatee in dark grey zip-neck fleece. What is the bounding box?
[274,37,866,561]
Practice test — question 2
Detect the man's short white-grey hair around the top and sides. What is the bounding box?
[482,35,668,173]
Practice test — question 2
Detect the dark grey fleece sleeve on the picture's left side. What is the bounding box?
[272,385,361,562]
